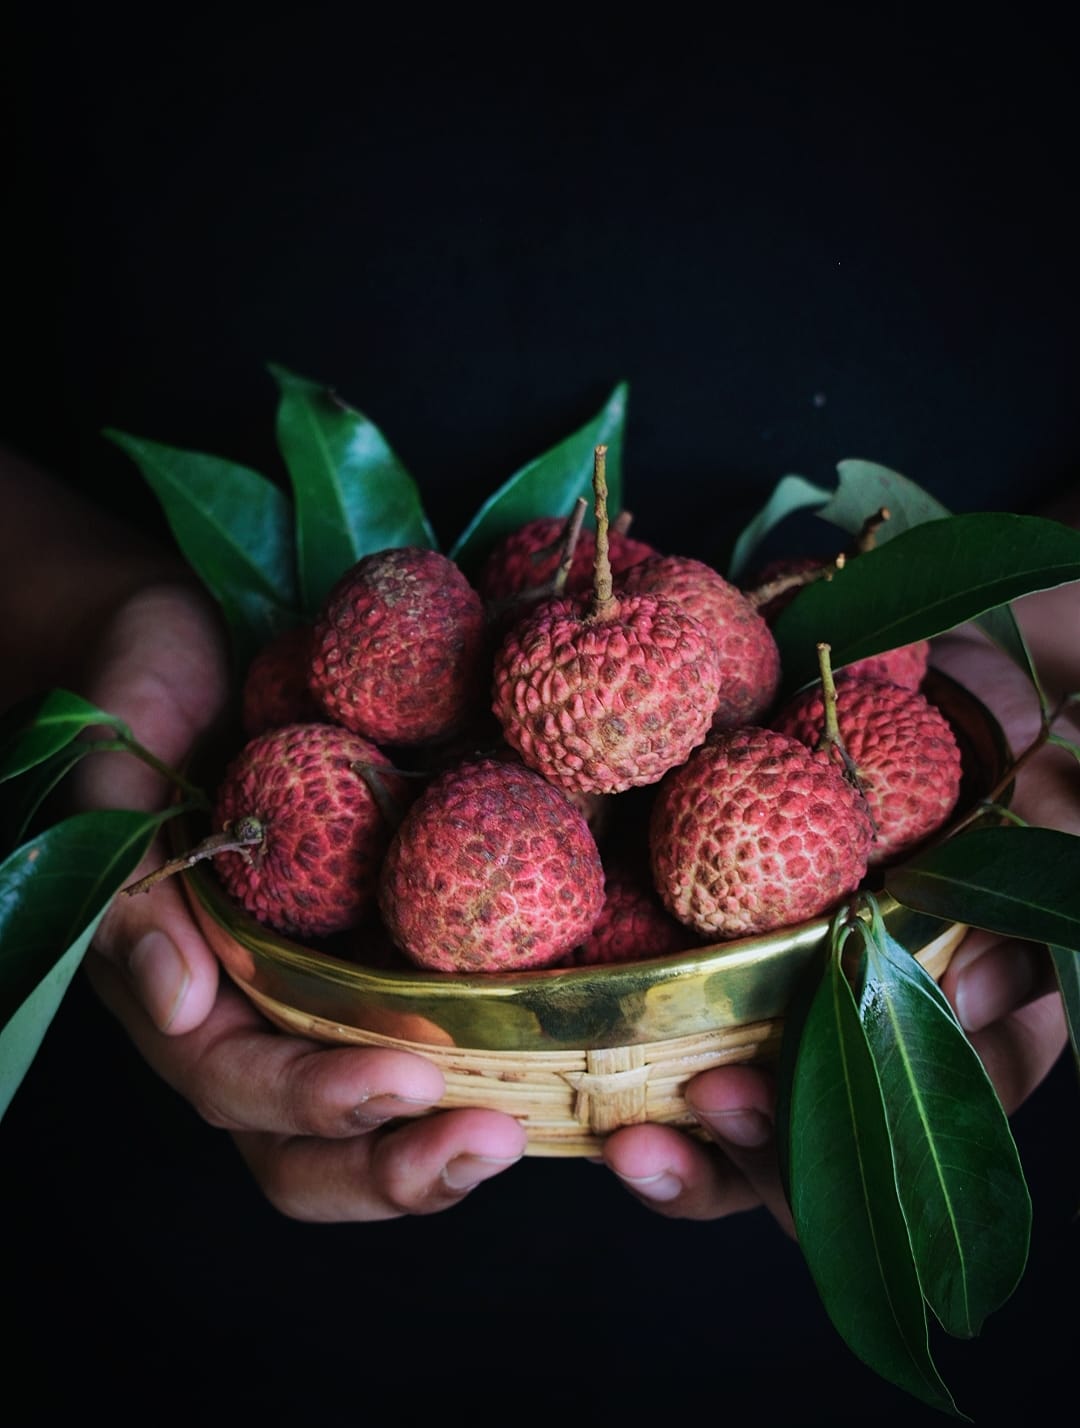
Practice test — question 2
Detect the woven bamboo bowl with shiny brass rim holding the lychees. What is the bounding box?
[177,670,1010,1155]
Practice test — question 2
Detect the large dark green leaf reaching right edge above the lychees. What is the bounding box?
[773,513,1080,698]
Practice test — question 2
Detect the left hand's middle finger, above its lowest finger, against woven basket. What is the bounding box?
[86,955,444,1140]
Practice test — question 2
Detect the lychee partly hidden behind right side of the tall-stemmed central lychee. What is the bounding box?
[616,555,780,730]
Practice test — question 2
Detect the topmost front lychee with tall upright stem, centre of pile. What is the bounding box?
[491,595,720,794]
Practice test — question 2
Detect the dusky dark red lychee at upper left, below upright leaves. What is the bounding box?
[310,545,486,745]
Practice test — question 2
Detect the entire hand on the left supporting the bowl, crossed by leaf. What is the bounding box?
[77,585,524,1221]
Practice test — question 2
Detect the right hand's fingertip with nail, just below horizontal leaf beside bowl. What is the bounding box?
[941,928,1057,1032]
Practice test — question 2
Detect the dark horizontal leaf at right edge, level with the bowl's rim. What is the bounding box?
[884,825,1080,951]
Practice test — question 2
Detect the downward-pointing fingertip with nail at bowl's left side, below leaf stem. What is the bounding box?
[93,844,219,1035]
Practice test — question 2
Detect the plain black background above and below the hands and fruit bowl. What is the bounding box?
[0,6,1080,1425]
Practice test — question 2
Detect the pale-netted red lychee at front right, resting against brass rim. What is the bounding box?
[649,728,873,940]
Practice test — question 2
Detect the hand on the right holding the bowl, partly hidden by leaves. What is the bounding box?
[603,587,1080,1235]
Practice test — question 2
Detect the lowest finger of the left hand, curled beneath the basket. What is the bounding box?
[236,1110,526,1222]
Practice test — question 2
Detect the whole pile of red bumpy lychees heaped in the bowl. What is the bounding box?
[185,447,960,974]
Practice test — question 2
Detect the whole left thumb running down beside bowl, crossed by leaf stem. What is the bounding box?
[74,585,227,1034]
